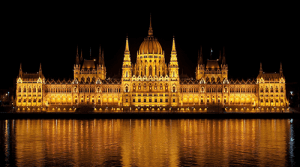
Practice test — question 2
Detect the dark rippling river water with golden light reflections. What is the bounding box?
[0,119,300,167]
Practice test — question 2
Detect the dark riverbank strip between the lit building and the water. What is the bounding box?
[0,113,300,119]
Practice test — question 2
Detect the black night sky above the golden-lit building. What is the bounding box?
[0,4,300,89]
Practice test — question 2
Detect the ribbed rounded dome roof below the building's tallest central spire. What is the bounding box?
[139,36,162,54]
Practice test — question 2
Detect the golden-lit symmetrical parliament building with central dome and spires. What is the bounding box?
[16,17,289,112]
